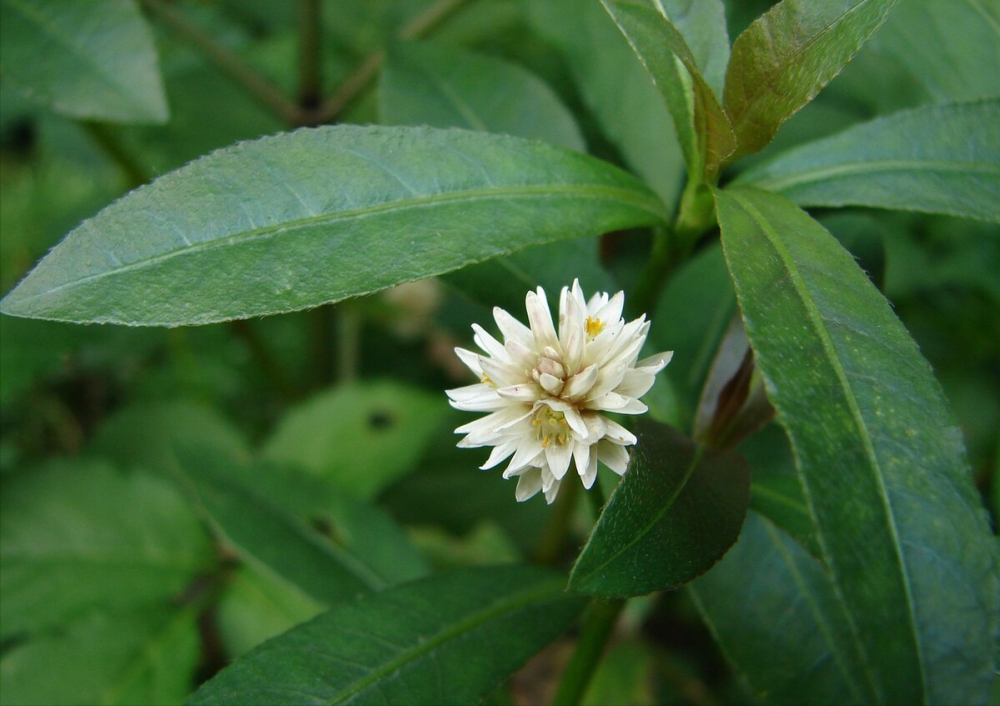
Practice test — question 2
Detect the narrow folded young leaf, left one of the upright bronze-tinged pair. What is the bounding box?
[601,0,736,179]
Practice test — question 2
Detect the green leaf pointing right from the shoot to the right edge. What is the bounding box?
[737,98,1000,223]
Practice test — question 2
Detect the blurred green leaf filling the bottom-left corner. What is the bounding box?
[0,608,201,706]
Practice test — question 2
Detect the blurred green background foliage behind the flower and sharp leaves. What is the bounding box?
[0,0,1000,704]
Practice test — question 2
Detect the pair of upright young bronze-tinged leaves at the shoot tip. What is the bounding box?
[602,0,897,183]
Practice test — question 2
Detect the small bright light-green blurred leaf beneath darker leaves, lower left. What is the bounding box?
[217,565,324,656]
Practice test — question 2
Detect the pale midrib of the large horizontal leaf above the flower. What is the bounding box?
[8,184,665,303]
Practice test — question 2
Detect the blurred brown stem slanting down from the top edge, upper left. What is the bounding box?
[140,0,302,125]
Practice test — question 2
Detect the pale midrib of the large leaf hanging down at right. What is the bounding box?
[727,191,927,693]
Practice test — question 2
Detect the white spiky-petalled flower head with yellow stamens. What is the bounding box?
[448,281,673,503]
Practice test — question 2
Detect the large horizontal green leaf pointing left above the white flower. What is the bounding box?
[0,125,664,325]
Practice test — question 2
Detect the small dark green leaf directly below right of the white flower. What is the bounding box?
[569,422,750,596]
